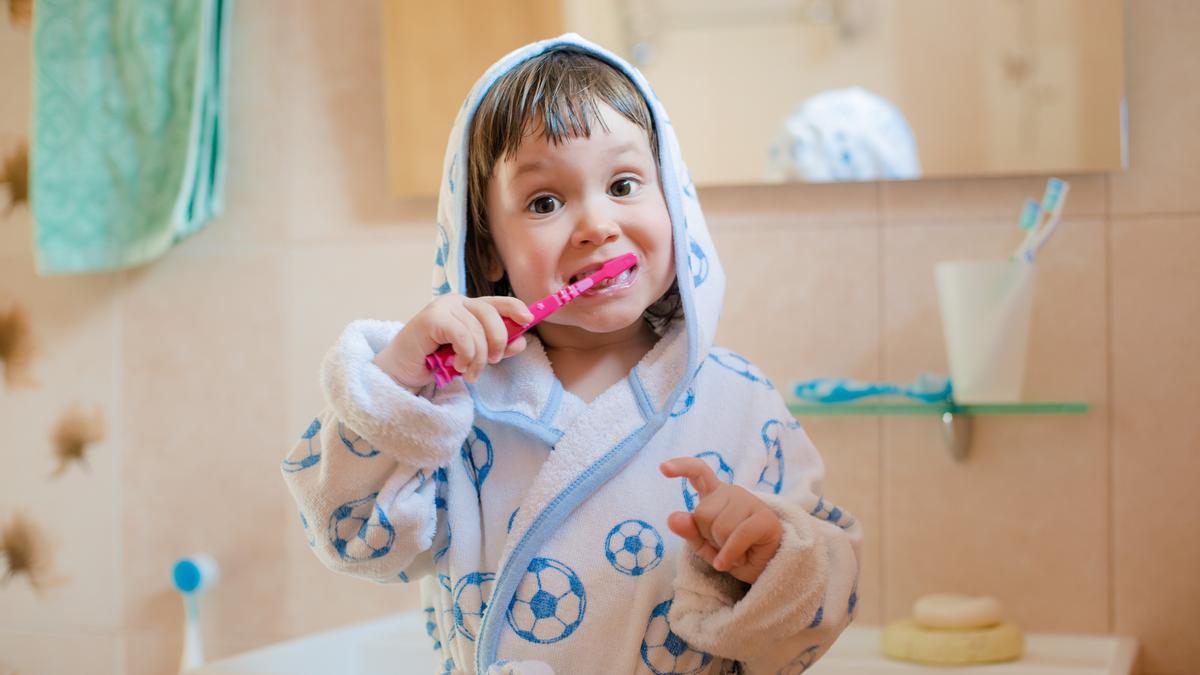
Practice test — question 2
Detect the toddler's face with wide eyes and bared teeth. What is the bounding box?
[487,103,674,333]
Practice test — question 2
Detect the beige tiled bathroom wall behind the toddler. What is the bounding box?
[0,0,1200,675]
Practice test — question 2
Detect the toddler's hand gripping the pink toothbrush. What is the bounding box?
[373,293,533,390]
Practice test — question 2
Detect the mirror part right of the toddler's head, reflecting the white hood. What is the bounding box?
[563,0,1126,186]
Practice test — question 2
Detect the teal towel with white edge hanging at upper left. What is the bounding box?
[30,0,232,274]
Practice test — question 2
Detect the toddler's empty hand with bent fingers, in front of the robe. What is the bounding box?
[659,456,784,584]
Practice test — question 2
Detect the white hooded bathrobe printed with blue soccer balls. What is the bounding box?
[282,35,862,675]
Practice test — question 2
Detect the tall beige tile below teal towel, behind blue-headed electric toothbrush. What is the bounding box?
[122,246,294,668]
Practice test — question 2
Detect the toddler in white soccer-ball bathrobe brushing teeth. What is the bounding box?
[282,35,862,675]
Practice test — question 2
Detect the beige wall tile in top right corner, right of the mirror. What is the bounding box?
[1112,0,1200,215]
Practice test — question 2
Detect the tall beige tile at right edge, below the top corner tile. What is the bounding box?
[1112,216,1200,674]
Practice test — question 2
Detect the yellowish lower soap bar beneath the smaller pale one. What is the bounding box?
[881,619,1025,665]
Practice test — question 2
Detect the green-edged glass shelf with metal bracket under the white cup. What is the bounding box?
[787,400,1088,461]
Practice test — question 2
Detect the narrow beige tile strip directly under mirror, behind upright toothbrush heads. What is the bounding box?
[881,174,1108,222]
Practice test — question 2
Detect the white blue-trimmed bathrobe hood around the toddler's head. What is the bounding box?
[433,34,725,407]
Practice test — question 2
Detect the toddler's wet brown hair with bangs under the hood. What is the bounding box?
[464,47,683,328]
